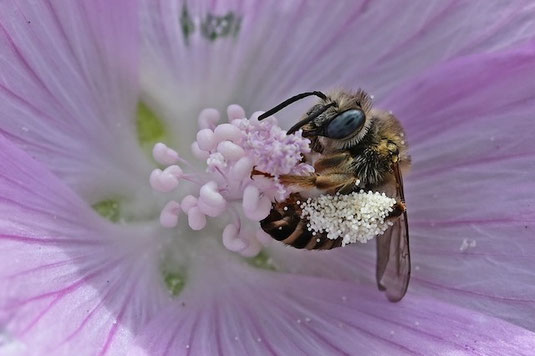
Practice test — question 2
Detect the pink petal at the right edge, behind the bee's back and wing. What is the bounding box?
[376,42,535,329]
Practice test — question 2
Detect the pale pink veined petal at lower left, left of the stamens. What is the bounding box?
[0,138,166,354]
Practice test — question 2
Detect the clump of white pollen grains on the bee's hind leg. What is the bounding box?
[300,190,396,246]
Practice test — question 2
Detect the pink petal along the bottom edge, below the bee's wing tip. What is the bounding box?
[130,262,535,355]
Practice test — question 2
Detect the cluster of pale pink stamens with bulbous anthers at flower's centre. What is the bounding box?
[150,105,314,256]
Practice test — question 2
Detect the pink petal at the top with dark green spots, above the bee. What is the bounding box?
[141,0,535,134]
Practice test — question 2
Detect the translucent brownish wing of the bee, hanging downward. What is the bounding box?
[376,162,411,302]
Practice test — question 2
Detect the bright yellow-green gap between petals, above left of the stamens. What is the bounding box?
[136,101,167,152]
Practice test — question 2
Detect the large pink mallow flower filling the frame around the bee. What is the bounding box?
[0,0,535,355]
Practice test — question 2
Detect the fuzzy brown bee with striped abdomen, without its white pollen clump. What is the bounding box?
[253,90,411,302]
